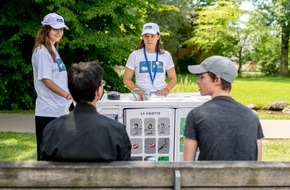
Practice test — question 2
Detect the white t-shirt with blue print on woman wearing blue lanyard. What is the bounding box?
[126,48,174,92]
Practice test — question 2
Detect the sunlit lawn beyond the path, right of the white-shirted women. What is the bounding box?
[172,74,290,119]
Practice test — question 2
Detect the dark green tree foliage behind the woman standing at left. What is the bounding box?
[0,0,178,109]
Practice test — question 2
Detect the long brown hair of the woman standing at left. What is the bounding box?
[33,25,58,62]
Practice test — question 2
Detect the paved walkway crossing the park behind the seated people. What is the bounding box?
[0,114,290,139]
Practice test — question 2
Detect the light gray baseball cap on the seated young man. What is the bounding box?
[188,55,237,83]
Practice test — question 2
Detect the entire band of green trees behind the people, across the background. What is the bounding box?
[0,0,290,110]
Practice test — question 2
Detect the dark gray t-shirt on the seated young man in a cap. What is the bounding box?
[184,96,264,160]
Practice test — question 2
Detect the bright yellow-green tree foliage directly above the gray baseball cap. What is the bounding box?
[186,0,249,75]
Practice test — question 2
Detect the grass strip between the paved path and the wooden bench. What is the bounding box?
[0,132,290,161]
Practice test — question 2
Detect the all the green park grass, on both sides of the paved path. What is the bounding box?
[0,74,290,161]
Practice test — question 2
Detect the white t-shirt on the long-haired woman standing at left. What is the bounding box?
[32,45,68,117]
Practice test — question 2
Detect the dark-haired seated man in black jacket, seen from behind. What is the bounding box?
[40,62,131,162]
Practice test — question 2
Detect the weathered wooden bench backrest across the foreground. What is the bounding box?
[0,161,290,190]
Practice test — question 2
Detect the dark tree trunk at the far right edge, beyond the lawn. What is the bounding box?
[280,25,290,76]
